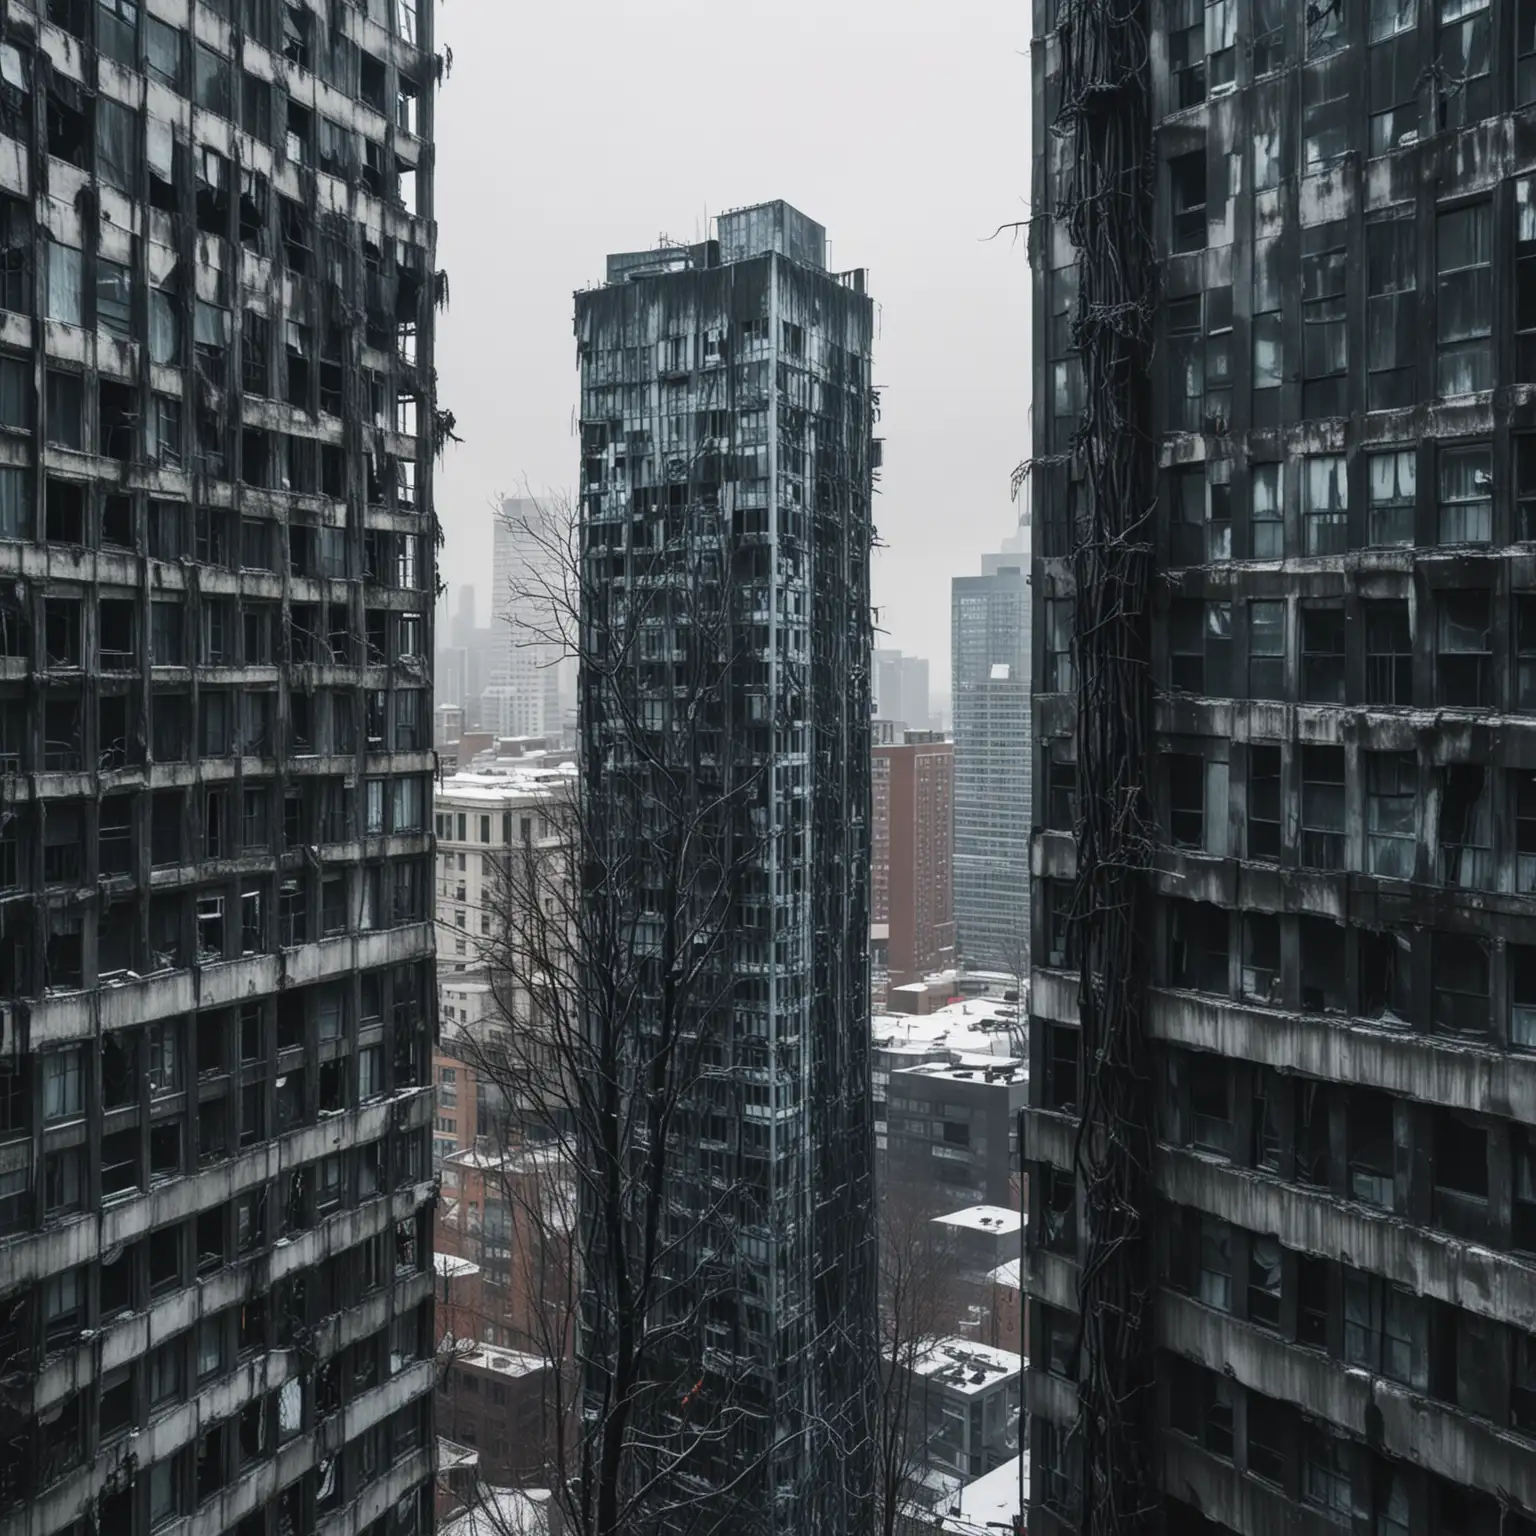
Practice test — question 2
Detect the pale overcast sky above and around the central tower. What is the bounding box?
[436,0,1031,697]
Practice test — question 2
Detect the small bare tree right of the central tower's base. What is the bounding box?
[876,1187,965,1536]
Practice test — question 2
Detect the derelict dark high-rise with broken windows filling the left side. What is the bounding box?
[0,0,438,1536]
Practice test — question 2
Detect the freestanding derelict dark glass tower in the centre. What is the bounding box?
[576,203,877,1533]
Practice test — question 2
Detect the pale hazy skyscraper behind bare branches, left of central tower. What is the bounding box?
[481,496,562,736]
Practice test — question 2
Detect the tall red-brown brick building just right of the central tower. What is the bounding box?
[869,722,955,986]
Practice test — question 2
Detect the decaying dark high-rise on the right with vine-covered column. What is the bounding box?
[1023,0,1536,1536]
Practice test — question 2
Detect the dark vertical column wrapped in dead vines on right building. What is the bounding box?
[1054,0,1161,1536]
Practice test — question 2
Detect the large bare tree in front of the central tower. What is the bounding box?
[461,482,776,1536]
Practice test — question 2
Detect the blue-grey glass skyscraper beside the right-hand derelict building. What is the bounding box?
[951,539,1032,974]
